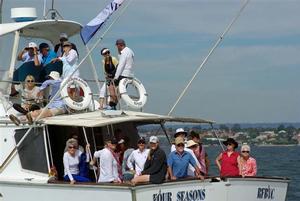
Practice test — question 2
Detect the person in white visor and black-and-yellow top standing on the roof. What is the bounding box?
[99,48,118,109]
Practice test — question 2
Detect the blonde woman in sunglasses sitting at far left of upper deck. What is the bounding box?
[13,75,42,115]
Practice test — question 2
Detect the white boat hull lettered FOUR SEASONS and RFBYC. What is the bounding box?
[0,178,289,201]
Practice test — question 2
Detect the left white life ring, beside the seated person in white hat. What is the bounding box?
[60,77,92,110]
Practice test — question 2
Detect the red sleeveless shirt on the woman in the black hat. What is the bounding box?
[221,151,239,177]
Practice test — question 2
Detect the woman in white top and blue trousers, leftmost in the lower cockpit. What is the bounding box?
[63,138,90,184]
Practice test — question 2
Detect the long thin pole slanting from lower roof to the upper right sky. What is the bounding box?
[168,0,250,115]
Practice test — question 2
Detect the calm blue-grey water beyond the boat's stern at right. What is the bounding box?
[206,146,300,201]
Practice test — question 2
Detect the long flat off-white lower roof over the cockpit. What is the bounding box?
[41,110,214,127]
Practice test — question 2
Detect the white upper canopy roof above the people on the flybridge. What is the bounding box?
[0,20,82,44]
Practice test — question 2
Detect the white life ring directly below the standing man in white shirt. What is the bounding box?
[119,78,148,109]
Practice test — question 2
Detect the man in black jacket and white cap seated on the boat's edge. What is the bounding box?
[131,136,167,184]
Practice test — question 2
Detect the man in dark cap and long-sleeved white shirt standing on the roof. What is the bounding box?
[114,39,134,86]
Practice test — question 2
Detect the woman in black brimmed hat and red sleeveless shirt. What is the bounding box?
[216,138,240,177]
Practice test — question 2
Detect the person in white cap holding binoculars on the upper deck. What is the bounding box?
[17,42,42,66]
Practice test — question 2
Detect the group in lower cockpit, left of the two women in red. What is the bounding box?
[64,128,212,184]
